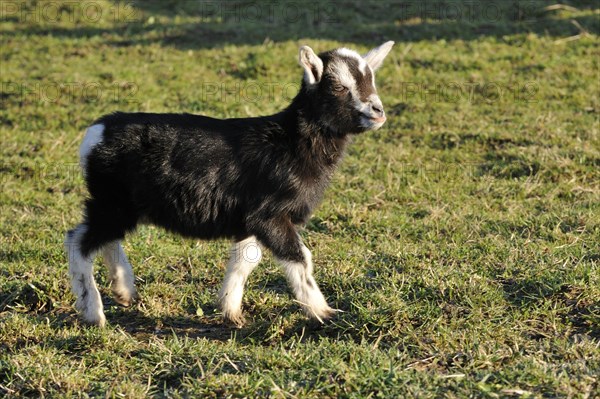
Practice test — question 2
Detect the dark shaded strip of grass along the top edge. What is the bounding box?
[2,0,600,50]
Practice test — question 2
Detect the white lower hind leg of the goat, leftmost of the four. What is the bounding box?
[65,224,106,327]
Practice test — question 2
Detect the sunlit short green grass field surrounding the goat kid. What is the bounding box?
[0,0,600,398]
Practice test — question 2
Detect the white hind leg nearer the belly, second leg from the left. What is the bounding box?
[102,241,136,306]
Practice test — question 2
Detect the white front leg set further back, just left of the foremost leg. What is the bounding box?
[219,237,262,326]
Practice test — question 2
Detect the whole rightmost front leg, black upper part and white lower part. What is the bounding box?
[254,219,335,323]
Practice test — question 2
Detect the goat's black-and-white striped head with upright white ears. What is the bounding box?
[300,41,394,133]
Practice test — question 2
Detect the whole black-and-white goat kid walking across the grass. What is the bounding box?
[65,42,394,326]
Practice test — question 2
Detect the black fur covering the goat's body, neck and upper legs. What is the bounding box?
[81,53,384,262]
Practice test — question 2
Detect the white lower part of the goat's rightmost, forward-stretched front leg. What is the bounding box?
[279,244,335,323]
